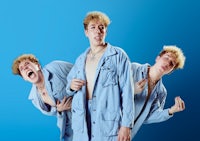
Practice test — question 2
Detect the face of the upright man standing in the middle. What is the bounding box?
[85,20,107,46]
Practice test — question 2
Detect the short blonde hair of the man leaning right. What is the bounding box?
[159,45,186,69]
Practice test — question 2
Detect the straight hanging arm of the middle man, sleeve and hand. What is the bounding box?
[118,51,134,141]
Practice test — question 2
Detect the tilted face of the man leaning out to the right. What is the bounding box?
[156,52,176,74]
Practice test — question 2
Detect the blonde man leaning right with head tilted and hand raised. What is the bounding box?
[132,46,185,141]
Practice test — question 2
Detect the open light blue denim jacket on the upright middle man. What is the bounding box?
[66,44,134,141]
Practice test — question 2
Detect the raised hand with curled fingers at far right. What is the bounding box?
[169,96,185,115]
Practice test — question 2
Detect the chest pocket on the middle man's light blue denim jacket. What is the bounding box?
[100,59,117,87]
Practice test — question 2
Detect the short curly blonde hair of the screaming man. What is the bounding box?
[12,54,39,75]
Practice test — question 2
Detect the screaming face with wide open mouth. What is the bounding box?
[19,59,40,83]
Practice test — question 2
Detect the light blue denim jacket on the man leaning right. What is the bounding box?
[132,63,172,141]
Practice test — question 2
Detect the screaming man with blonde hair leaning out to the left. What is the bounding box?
[12,54,73,141]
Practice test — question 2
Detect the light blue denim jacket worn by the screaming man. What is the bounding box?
[28,61,72,141]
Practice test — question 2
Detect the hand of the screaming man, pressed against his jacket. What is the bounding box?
[56,96,72,112]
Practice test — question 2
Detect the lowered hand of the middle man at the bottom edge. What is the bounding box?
[117,126,131,141]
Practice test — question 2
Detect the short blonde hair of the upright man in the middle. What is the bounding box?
[83,11,110,30]
